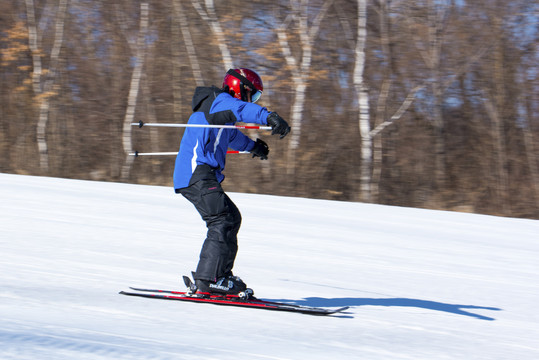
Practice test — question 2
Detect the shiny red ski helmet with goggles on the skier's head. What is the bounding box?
[223,68,264,103]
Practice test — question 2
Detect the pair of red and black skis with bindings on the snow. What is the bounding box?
[120,276,348,315]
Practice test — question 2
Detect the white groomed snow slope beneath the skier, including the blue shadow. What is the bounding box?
[0,174,539,360]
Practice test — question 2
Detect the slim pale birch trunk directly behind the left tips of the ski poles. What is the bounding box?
[121,2,149,181]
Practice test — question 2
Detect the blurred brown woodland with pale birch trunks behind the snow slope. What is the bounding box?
[0,0,539,218]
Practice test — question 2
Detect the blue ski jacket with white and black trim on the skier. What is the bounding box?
[173,86,269,192]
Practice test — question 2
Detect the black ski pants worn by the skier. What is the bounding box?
[179,173,241,281]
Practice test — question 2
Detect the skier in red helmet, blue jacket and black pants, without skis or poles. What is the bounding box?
[173,68,290,294]
